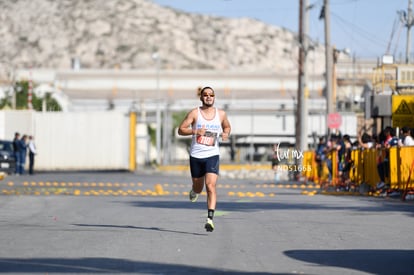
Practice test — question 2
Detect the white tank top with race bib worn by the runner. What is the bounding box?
[190,108,223,158]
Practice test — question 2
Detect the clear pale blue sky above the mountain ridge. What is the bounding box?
[153,0,414,58]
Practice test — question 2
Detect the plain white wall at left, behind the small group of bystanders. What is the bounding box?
[0,111,129,170]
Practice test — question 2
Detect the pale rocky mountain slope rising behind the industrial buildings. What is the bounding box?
[0,0,324,73]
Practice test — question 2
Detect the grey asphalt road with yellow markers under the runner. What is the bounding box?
[0,173,414,274]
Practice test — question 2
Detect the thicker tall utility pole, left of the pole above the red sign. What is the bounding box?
[296,0,308,152]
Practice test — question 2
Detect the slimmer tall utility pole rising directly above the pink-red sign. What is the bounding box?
[323,0,335,132]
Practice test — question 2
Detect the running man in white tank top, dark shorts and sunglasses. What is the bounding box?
[178,87,231,232]
